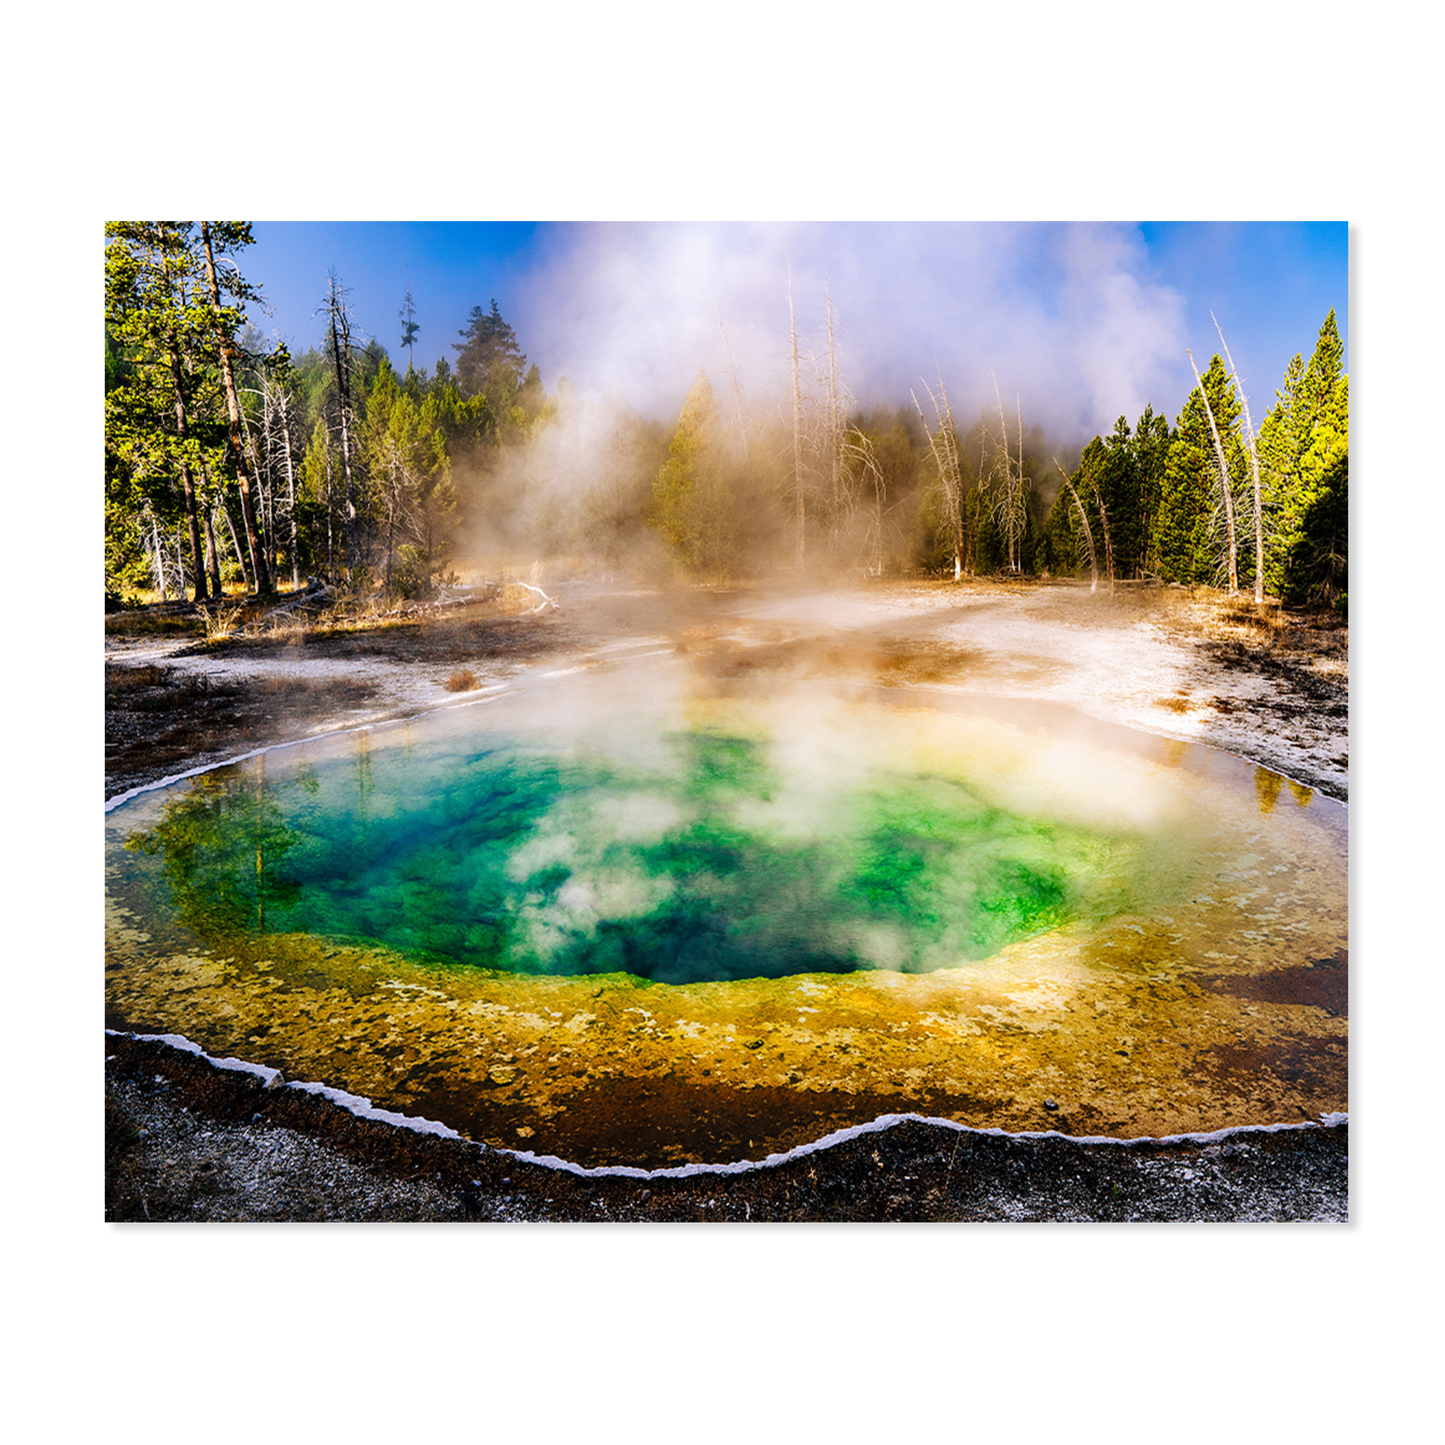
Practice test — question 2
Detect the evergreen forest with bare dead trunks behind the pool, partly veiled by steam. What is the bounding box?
[101,220,1350,611]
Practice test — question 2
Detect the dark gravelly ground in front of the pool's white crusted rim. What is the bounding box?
[101,1035,1350,1224]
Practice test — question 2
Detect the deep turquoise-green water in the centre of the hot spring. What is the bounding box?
[127,702,1131,983]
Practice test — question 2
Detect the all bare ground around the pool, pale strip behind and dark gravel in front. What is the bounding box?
[101,582,1348,1222]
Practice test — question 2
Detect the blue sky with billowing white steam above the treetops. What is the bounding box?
[241,220,1350,438]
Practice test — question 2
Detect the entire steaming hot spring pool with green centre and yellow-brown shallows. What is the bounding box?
[101,666,1348,1166]
